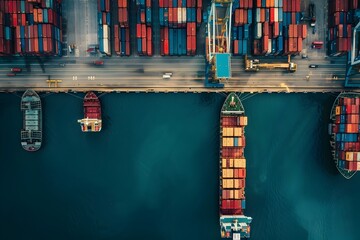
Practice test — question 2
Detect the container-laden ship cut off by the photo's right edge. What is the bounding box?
[329,92,360,179]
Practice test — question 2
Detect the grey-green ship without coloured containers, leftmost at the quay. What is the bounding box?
[21,89,42,152]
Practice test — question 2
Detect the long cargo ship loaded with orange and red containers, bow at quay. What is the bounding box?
[219,93,252,239]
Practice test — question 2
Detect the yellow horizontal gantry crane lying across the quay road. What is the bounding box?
[245,55,297,72]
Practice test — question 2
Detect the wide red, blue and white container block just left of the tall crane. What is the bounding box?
[159,0,202,56]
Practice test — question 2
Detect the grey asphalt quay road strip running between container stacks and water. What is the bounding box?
[0,54,352,91]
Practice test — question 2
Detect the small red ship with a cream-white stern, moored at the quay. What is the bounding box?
[78,92,102,132]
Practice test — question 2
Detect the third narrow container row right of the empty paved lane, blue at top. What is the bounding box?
[136,0,153,56]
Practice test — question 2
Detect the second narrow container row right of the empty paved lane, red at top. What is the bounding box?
[114,0,130,56]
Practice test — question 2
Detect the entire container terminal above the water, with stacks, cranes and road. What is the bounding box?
[0,0,360,92]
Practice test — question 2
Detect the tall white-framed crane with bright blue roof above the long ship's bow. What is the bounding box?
[205,0,233,87]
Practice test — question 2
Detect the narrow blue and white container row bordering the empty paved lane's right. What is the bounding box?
[98,0,111,56]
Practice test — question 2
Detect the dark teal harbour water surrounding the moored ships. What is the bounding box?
[0,93,360,240]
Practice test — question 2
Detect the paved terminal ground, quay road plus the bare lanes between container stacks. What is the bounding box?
[0,0,360,92]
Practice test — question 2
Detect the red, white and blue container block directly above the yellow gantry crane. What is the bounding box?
[253,0,307,55]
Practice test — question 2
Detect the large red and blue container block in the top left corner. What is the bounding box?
[0,0,62,56]
